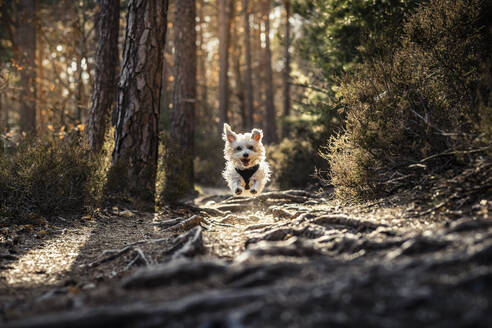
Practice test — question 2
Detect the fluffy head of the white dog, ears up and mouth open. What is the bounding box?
[222,123,265,169]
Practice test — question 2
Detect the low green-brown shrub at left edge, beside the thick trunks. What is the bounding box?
[0,139,104,221]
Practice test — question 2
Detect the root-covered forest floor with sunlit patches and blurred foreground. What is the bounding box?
[0,186,492,328]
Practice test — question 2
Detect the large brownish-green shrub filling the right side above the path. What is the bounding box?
[324,0,492,197]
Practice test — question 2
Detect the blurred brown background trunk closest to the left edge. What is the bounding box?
[16,0,36,135]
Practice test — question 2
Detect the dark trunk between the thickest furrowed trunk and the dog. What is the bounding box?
[162,0,197,202]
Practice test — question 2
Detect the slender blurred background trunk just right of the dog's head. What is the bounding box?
[264,0,278,143]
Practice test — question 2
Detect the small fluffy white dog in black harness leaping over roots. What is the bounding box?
[222,123,270,196]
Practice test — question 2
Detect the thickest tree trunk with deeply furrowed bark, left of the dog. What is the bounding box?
[108,0,168,209]
